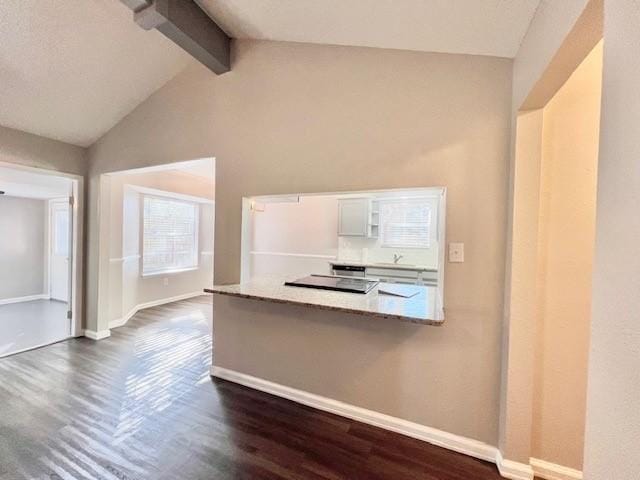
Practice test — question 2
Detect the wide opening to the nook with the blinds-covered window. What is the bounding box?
[95,158,215,339]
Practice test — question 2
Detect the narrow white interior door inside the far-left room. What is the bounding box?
[49,199,71,302]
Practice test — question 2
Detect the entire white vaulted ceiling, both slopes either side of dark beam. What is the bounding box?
[0,0,540,146]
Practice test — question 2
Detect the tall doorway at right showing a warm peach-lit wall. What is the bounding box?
[508,41,603,477]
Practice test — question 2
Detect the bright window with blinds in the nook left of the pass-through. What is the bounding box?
[142,195,199,275]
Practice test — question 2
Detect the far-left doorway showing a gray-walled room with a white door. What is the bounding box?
[0,164,82,357]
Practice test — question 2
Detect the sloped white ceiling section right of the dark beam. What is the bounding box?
[196,0,540,57]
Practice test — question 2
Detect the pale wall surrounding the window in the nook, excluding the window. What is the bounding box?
[108,171,214,324]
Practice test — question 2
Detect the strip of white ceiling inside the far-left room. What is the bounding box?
[0,166,71,200]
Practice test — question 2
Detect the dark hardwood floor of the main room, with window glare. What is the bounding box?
[0,297,510,480]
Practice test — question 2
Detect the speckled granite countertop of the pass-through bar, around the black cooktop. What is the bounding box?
[204,277,444,326]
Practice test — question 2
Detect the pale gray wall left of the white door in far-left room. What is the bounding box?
[0,196,47,300]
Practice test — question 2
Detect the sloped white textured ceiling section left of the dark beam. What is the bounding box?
[0,0,190,146]
